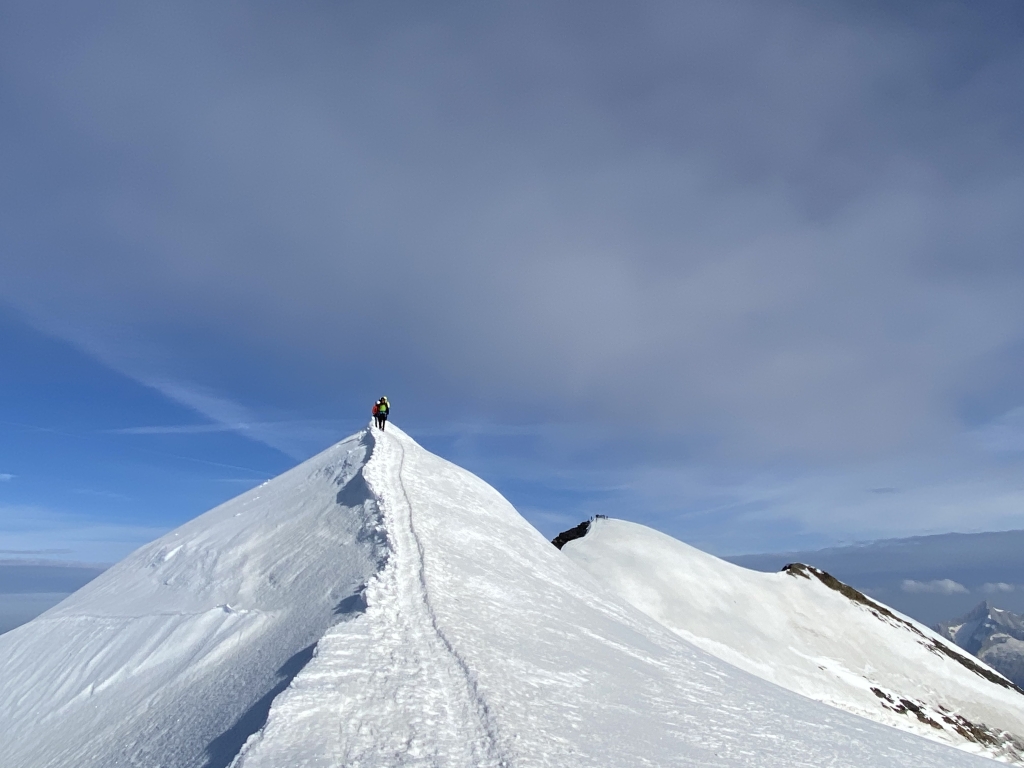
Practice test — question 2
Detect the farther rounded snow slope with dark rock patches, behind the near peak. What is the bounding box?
[563,519,1024,764]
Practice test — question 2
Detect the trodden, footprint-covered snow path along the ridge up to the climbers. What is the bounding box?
[234,434,509,768]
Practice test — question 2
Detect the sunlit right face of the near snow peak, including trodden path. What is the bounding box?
[236,424,989,768]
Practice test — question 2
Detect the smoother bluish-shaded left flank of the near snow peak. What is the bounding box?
[0,432,386,768]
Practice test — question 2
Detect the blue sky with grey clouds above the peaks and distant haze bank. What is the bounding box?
[0,0,1024,561]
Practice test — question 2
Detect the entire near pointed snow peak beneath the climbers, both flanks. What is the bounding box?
[0,425,1007,768]
